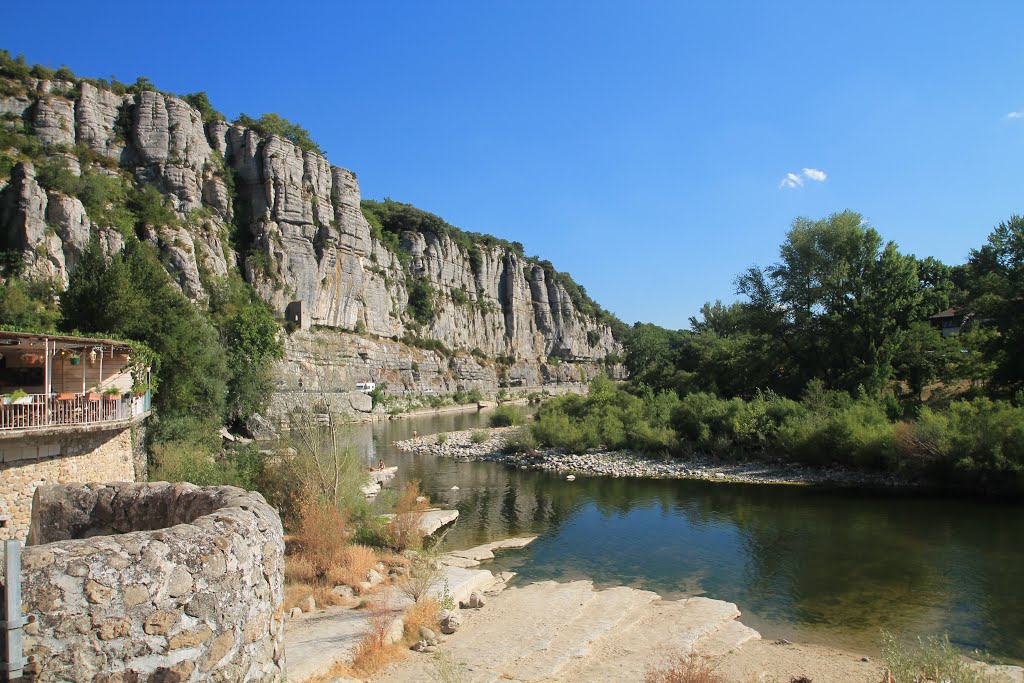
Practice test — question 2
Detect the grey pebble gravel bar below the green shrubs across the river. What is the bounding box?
[395,427,921,488]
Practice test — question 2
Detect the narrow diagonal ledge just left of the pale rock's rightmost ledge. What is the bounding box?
[502,587,659,681]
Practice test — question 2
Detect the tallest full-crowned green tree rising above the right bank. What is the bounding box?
[737,211,921,391]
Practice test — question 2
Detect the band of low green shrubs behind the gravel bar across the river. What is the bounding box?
[532,379,1024,490]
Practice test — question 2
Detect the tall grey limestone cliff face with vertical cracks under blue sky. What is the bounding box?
[0,74,620,395]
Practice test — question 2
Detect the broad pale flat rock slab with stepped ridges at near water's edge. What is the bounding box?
[371,581,760,683]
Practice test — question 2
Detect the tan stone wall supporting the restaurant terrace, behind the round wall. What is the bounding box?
[0,427,135,541]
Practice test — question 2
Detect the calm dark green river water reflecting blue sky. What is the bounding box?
[352,405,1024,663]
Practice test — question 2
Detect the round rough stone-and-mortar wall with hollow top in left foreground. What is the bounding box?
[23,482,285,683]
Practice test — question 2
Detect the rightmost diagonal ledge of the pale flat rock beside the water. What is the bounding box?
[552,597,739,683]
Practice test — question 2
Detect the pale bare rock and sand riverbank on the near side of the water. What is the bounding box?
[368,538,1024,683]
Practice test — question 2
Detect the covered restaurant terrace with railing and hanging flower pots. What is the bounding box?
[0,332,151,438]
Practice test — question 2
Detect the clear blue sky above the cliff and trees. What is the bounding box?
[0,0,1024,328]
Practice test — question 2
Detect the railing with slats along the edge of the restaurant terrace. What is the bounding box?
[0,392,150,431]
